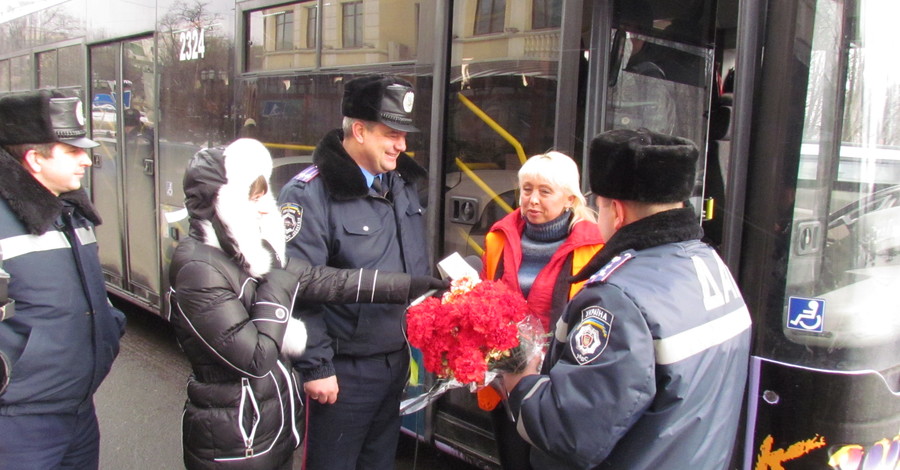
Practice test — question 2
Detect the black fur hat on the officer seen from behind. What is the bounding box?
[589,129,699,203]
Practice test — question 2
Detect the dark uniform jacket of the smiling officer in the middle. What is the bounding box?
[278,129,430,381]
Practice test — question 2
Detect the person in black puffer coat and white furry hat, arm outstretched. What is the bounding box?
[169,139,443,470]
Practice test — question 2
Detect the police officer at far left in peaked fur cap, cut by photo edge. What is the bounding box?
[0,90,125,470]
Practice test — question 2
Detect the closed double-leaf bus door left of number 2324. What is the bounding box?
[90,37,160,309]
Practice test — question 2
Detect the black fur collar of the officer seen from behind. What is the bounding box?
[569,207,703,283]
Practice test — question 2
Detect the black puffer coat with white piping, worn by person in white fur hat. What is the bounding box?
[170,239,409,469]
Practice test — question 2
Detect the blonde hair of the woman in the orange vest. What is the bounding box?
[519,150,597,225]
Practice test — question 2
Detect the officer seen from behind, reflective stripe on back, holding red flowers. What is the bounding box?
[504,129,750,470]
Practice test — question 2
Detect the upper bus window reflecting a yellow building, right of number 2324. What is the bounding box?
[244,0,419,72]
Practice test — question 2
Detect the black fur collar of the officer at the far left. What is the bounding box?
[0,148,101,235]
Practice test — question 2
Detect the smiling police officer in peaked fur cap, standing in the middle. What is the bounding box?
[279,76,429,470]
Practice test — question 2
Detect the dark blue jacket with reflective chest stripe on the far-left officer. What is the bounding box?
[0,149,125,415]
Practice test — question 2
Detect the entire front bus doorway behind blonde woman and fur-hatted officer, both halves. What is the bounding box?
[434,0,715,459]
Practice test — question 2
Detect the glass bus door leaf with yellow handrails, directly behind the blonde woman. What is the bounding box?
[432,1,591,464]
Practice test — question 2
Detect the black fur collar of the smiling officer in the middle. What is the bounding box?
[313,129,427,201]
